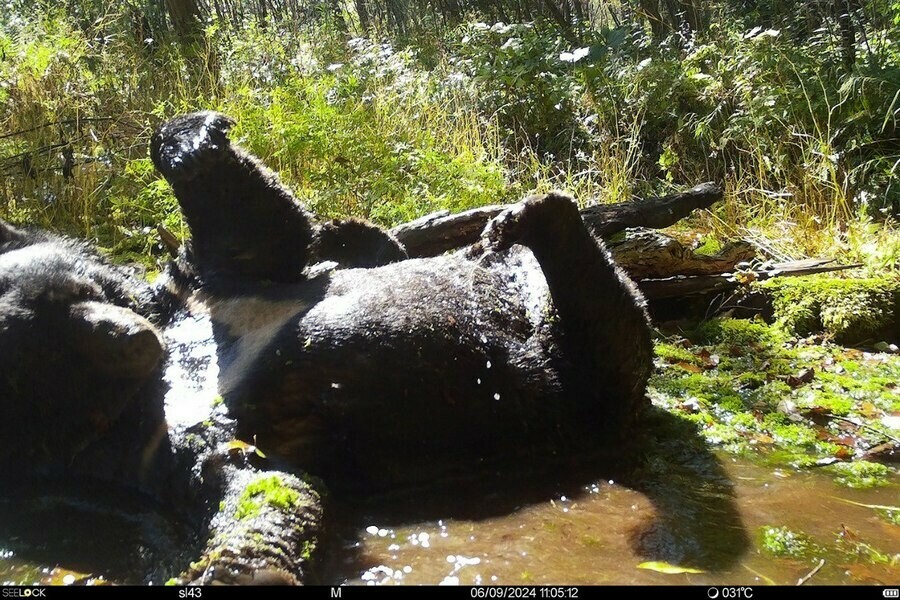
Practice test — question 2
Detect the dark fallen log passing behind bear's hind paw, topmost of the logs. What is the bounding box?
[391,183,722,258]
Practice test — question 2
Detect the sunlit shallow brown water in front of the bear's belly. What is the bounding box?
[332,455,900,585]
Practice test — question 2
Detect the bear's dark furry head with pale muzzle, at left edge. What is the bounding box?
[0,221,164,469]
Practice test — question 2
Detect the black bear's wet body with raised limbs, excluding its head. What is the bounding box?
[151,112,652,490]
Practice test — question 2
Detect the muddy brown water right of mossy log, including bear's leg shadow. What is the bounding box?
[329,411,900,585]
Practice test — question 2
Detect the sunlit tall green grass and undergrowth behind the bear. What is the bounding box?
[0,12,900,267]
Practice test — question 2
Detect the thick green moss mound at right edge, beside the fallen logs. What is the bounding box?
[758,277,900,342]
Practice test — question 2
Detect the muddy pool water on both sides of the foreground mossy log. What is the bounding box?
[0,455,900,585]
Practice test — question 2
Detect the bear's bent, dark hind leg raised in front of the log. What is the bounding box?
[482,193,653,437]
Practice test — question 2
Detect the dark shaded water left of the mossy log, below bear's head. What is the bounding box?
[0,484,193,585]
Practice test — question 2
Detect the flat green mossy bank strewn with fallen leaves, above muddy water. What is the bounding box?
[648,319,900,468]
